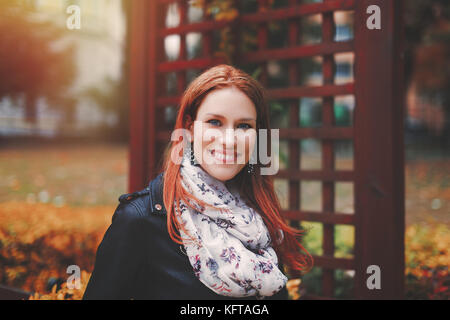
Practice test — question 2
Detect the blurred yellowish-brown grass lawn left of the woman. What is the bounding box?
[0,144,128,206]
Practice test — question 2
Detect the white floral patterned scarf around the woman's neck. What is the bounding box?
[175,151,287,299]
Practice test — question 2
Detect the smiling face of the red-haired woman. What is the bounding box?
[191,87,257,182]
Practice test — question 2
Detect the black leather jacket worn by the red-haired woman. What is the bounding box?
[83,173,288,300]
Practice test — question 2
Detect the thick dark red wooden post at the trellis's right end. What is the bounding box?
[354,0,405,299]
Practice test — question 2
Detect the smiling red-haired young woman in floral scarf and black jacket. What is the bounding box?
[83,65,312,299]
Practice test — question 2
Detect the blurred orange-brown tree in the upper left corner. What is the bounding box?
[0,0,76,123]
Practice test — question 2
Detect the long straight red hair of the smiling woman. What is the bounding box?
[162,65,313,274]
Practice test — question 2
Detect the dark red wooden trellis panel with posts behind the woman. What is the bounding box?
[129,0,404,299]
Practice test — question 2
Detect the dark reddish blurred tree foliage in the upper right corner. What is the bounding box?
[405,0,450,143]
